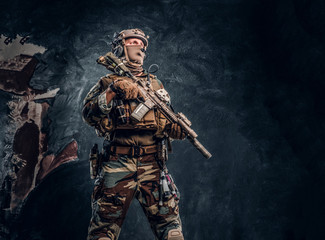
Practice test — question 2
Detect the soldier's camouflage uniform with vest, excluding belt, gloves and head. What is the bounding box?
[83,74,183,240]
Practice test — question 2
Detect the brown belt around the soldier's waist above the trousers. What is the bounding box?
[110,145,158,157]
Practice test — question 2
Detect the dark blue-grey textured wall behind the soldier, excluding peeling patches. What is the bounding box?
[0,0,325,240]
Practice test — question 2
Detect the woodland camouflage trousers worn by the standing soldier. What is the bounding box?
[87,154,182,240]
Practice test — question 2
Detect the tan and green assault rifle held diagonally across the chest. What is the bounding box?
[97,52,212,158]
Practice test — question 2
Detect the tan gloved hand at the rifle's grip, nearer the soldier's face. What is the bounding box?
[110,80,139,99]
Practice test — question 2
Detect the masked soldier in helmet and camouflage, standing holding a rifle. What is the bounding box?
[83,29,185,240]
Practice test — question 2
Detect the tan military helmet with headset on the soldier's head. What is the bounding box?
[112,28,149,57]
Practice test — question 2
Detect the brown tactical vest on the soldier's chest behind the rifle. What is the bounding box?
[98,74,167,135]
